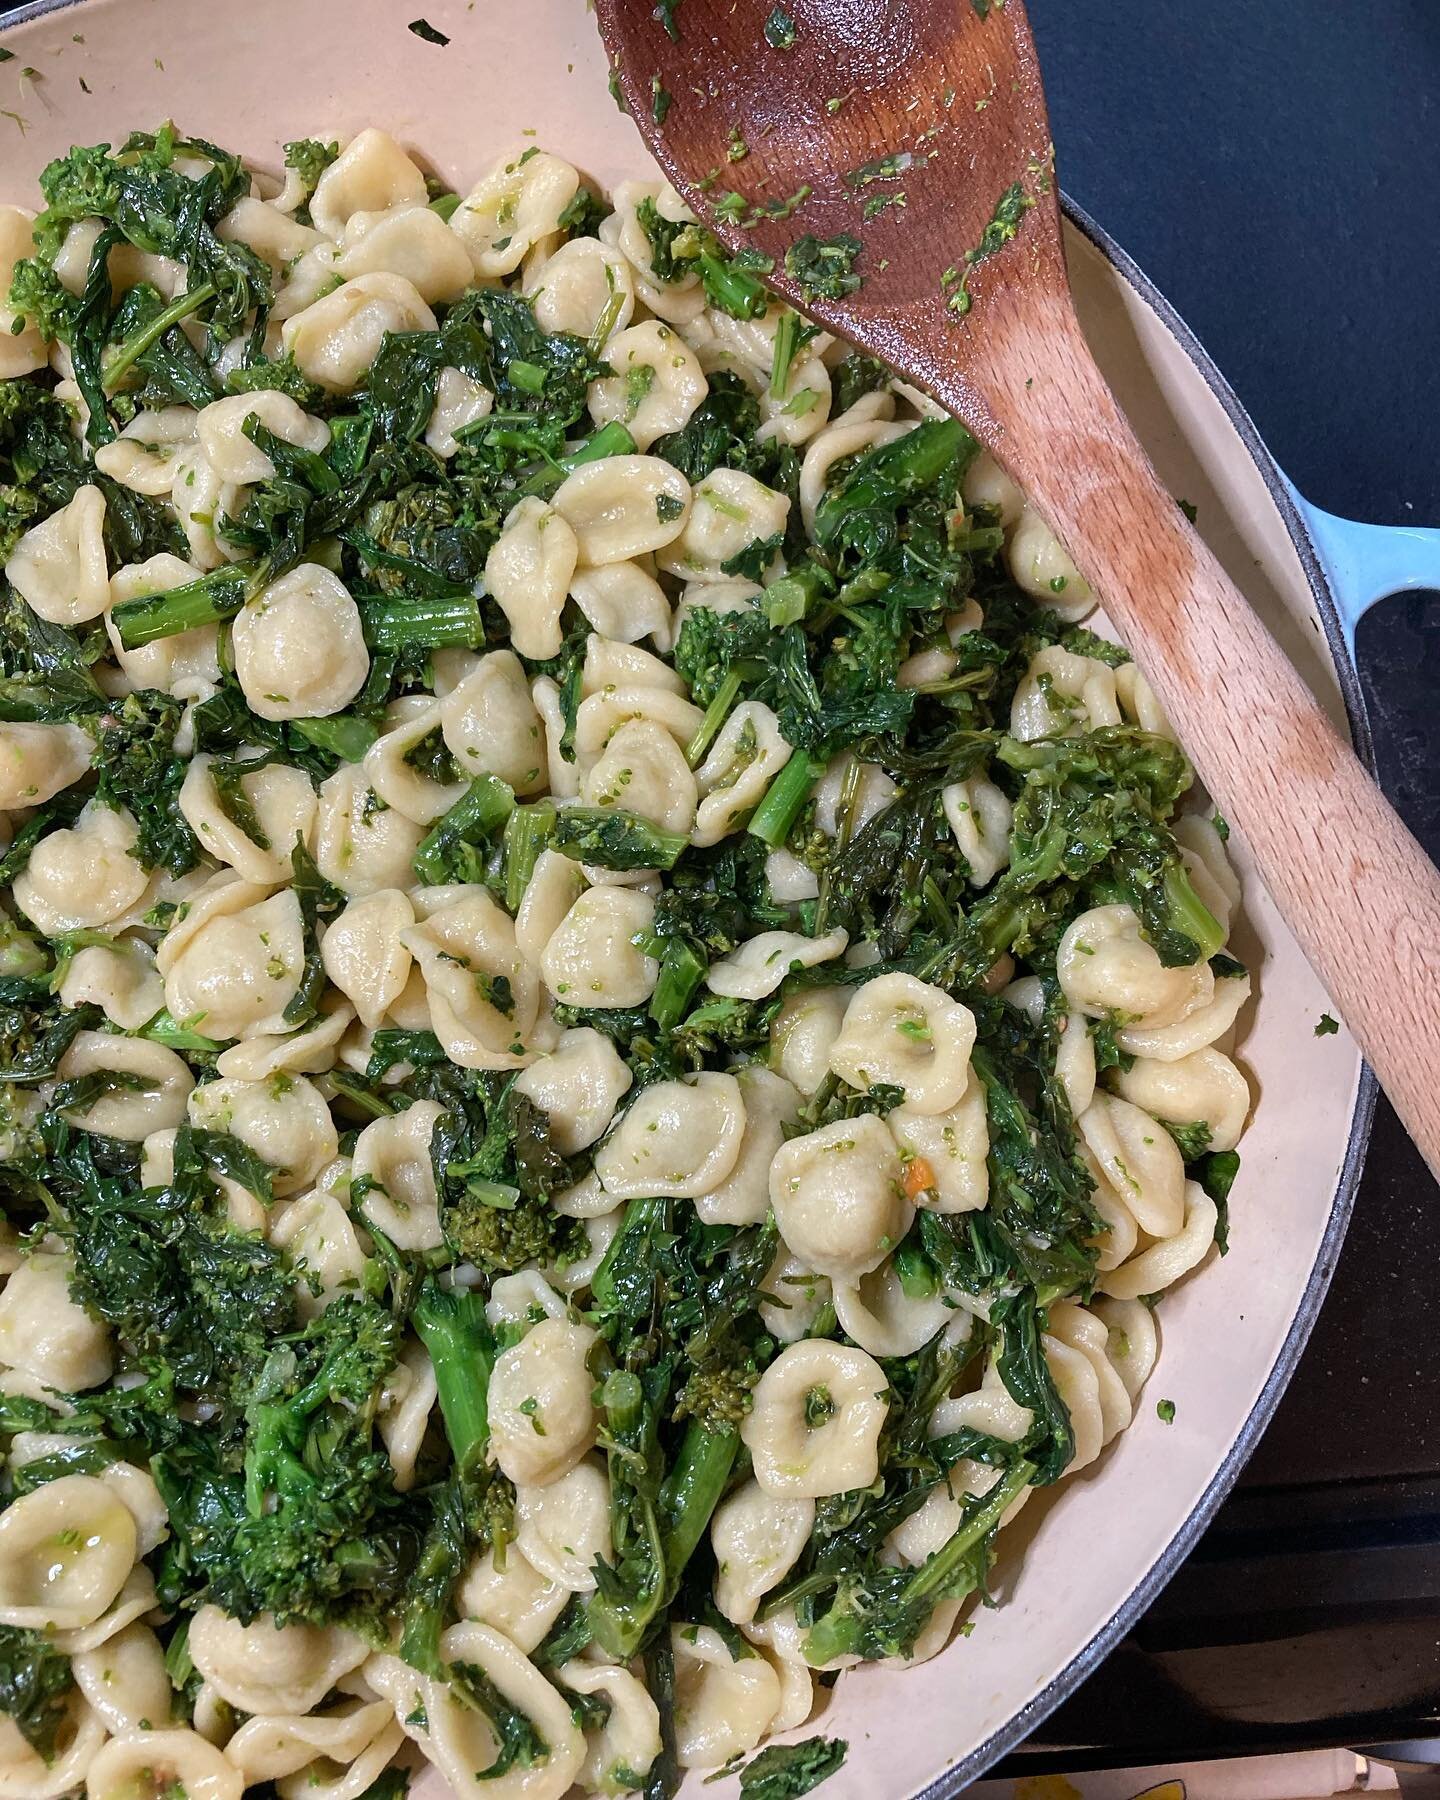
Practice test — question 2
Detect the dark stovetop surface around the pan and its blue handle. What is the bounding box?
[1010,0,1440,1773]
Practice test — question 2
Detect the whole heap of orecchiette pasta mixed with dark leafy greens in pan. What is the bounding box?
[0,123,1251,1800]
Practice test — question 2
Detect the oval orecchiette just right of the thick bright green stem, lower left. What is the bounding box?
[482,1319,598,1483]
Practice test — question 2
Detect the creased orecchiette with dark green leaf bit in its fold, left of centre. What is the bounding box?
[401,887,540,1069]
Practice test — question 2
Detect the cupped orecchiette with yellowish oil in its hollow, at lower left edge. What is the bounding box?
[0,1474,139,1631]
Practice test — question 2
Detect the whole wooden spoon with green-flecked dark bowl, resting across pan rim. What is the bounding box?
[594,0,1440,1175]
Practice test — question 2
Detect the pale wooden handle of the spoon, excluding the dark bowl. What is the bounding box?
[986,320,1440,1177]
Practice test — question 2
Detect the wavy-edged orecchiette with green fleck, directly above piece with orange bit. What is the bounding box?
[830,972,976,1112]
